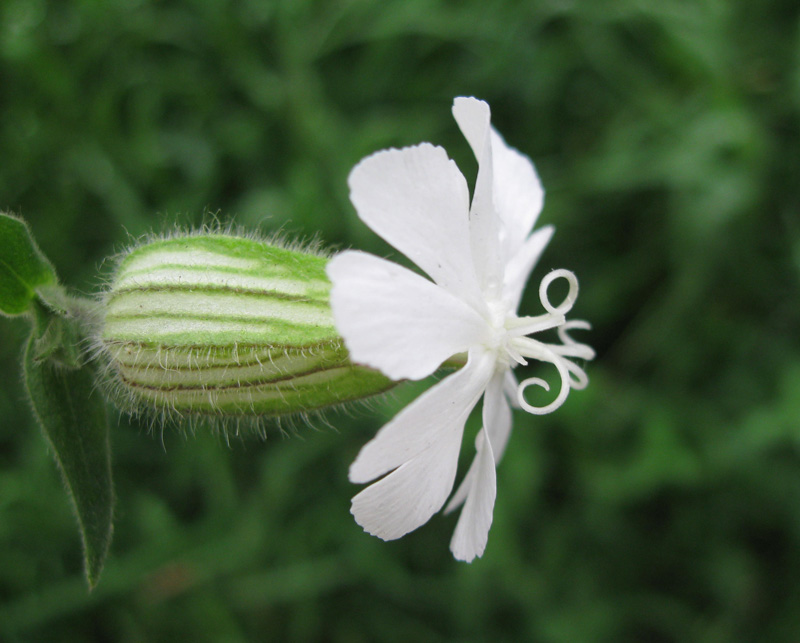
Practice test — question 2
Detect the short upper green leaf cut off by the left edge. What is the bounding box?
[0,212,56,315]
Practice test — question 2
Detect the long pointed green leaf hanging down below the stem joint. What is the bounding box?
[24,317,114,588]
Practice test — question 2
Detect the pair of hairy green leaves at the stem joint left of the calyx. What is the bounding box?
[0,213,113,587]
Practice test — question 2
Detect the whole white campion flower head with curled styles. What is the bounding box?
[327,98,594,561]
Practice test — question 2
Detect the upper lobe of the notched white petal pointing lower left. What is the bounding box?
[350,352,494,482]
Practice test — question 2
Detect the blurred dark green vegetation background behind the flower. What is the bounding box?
[0,0,800,642]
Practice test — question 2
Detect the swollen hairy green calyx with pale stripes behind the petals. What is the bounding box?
[100,234,394,416]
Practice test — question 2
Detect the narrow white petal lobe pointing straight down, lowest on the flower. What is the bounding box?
[450,433,497,563]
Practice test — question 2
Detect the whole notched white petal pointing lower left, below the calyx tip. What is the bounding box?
[350,355,493,540]
